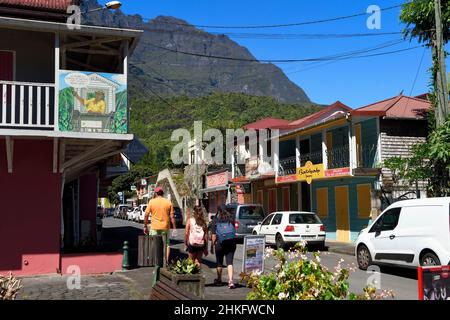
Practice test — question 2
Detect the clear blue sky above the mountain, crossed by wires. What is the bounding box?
[100,0,450,108]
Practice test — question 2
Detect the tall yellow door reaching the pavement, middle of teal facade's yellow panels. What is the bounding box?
[334,186,350,242]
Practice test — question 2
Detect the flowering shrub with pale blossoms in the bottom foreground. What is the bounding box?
[241,243,393,300]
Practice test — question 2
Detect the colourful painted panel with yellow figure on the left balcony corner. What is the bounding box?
[58,70,128,133]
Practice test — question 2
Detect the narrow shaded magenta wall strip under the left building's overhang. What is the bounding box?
[80,173,97,241]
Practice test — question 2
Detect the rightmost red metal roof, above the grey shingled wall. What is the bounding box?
[352,94,430,119]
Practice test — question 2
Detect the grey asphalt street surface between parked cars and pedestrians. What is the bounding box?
[104,218,418,300]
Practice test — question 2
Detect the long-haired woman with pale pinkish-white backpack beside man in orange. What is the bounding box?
[184,206,208,266]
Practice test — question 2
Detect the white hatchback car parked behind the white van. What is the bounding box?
[253,211,326,248]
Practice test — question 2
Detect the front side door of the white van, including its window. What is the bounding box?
[369,208,402,263]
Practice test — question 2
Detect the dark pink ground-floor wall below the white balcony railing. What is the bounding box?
[0,139,61,275]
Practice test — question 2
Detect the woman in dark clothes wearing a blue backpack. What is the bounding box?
[211,205,236,289]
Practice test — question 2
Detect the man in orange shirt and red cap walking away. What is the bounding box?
[144,187,177,264]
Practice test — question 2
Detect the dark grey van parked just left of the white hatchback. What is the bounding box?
[210,203,265,239]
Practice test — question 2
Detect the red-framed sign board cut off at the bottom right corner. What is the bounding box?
[417,266,450,300]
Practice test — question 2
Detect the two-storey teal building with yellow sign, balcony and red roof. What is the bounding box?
[236,94,430,242]
